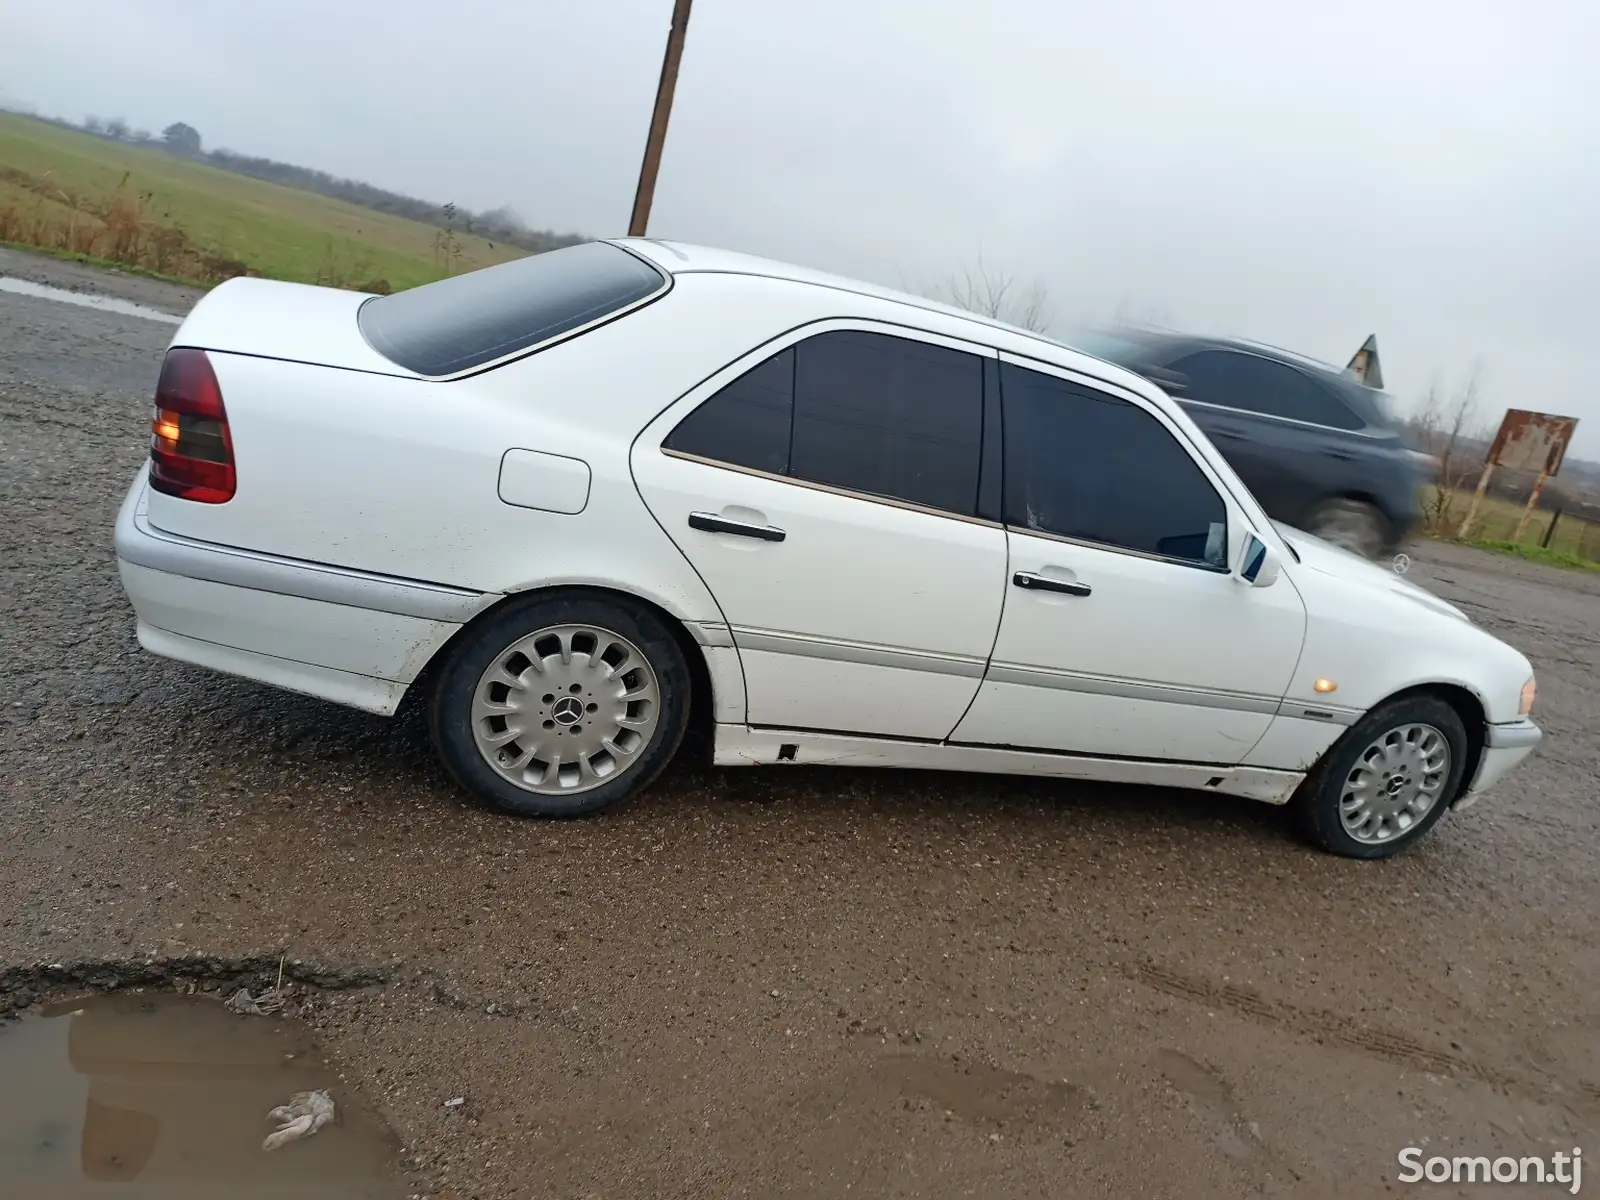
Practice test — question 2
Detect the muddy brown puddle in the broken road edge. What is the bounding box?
[0,994,398,1200]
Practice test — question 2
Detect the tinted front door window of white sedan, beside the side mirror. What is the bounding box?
[1000,363,1227,570]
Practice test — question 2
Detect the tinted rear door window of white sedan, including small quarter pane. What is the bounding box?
[662,330,984,517]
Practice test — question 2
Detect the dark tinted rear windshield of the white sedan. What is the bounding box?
[357,242,667,376]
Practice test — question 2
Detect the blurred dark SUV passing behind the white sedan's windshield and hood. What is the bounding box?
[1066,330,1422,558]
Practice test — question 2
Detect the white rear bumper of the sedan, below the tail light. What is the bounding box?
[115,470,496,715]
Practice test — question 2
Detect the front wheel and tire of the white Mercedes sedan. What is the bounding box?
[1290,694,1467,859]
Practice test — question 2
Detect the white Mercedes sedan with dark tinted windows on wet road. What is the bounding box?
[115,240,1541,858]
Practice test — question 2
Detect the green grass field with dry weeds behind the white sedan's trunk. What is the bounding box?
[0,112,523,290]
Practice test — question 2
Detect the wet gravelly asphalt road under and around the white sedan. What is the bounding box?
[0,251,1600,1197]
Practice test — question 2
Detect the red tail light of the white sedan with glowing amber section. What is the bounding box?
[150,347,237,504]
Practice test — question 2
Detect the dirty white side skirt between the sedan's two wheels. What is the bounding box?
[714,723,1306,805]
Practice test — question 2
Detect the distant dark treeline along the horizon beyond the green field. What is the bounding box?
[4,109,589,253]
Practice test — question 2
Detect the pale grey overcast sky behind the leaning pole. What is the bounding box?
[0,0,1600,458]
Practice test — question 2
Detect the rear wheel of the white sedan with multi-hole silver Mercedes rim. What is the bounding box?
[429,590,693,816]
